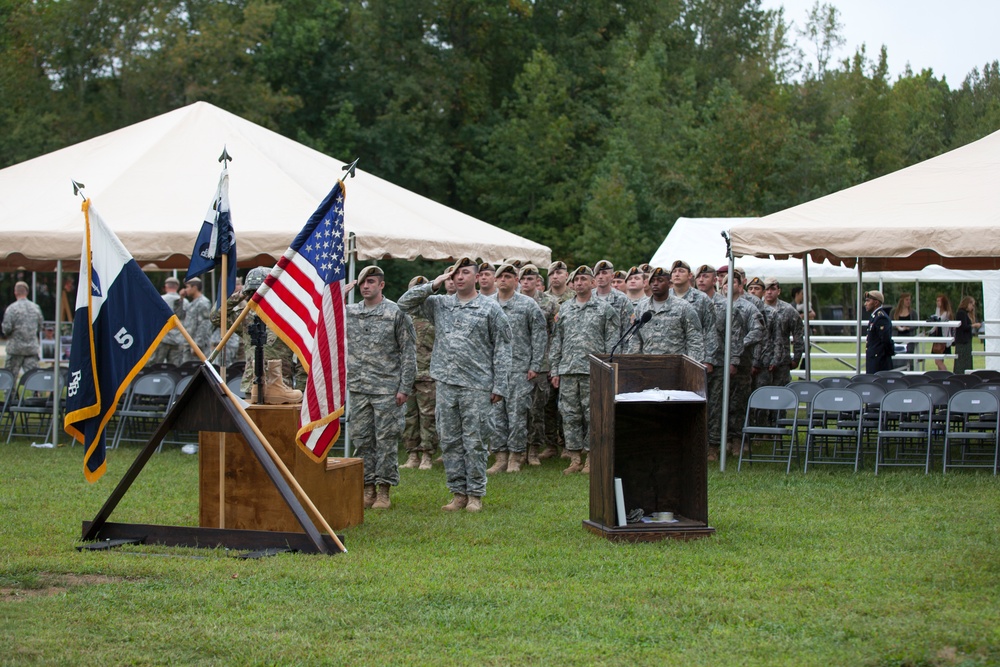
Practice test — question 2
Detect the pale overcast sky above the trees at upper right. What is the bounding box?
[761,0,1000,90]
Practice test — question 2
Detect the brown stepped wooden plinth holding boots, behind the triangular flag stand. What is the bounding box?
[198,405,364,533]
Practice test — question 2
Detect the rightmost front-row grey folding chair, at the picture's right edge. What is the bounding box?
[942,389,1000,475]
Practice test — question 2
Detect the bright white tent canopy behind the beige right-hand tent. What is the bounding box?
[649,218,996,283]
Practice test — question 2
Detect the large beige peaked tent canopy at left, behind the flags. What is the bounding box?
[0,102,551,270]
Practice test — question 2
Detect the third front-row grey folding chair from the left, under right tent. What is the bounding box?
[875,389,934,475]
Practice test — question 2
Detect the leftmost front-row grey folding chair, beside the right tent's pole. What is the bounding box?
[736,387,799,474]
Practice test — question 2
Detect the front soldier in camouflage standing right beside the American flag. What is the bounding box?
[344,266,417,509]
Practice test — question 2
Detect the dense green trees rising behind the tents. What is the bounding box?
[0,0,1000,274]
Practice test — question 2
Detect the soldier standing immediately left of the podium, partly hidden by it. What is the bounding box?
[549,266,621,475]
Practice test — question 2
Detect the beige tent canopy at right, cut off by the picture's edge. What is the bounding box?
[732,132,1000,271]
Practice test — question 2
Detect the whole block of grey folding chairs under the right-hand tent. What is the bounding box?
[737,382,1000,474]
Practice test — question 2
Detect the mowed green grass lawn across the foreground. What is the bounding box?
[0,442,1000,666]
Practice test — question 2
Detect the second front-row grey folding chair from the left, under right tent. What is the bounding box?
[805,389,863,472]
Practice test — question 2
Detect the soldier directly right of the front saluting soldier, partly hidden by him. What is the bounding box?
[486,264,549,474]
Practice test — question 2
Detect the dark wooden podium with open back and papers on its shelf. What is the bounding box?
[583,355,715,542]
